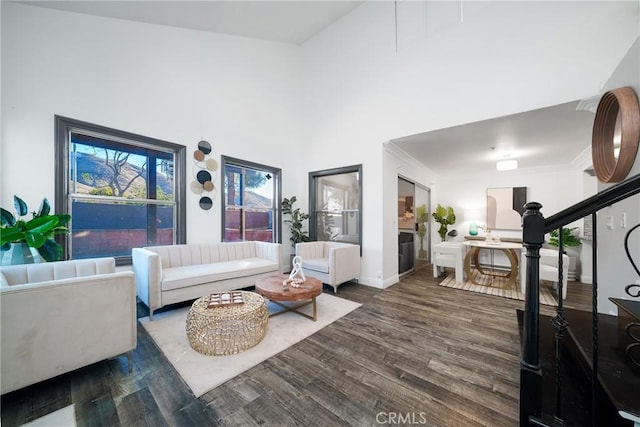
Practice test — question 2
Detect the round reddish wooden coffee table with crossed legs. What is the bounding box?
[256,275,322,322]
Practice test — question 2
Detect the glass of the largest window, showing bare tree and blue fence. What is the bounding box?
[69,134,174,258]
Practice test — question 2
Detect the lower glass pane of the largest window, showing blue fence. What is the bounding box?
[71,200,174,259]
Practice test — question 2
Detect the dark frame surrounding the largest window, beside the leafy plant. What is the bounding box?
[55,115,187,266]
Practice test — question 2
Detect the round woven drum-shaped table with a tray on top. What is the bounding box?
[186,291,269,356]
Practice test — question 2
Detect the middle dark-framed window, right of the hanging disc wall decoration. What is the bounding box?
[222,156,282,242]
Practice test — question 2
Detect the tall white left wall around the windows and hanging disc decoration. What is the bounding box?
[0,2,306,260]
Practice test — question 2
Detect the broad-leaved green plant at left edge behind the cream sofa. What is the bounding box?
[0,196,71,261]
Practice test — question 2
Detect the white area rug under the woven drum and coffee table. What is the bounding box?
[140,293,361,397]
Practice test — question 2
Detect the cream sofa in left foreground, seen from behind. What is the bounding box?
[0,258,137,394]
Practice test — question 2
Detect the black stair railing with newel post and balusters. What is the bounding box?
[520,174,640,427]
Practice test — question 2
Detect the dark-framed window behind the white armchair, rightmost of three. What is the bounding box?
[309,165,362,253]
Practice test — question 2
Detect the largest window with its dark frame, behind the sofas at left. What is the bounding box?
[56,116,186,265]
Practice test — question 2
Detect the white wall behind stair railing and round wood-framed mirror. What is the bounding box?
[594,40,640,314]
